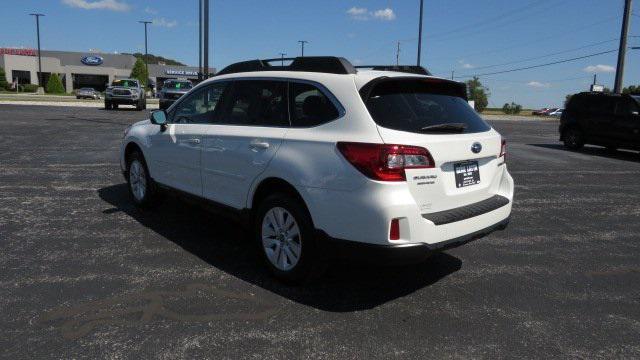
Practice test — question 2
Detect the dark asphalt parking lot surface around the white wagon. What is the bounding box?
[0,104,640,359]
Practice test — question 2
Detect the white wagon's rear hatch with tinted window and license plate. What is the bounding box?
[361,77,504,213]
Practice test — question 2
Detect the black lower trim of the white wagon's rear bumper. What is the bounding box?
[318,218,510,264]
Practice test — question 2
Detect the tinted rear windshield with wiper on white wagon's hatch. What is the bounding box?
[365,79,491,133]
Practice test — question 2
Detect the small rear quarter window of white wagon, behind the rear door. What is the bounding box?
[289,82,339,127]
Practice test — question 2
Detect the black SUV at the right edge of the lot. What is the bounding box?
[560,92,640,150]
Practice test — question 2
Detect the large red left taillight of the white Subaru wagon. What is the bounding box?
[337,142,434,181]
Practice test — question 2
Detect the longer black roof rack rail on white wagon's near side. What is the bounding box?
[216,56,356,75]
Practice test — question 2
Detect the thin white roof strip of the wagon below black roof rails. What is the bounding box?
[205,70,450,89]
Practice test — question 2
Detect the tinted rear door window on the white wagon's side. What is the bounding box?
[220,80,289,127]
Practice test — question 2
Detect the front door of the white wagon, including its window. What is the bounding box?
[151,85,225,196]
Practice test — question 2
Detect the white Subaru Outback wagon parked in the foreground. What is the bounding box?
[120,57,514,281]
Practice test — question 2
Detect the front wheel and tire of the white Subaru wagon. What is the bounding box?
[127,151,160,208]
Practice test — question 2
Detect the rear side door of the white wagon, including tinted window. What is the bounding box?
[202,79,289,209]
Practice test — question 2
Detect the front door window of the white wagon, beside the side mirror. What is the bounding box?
[170,82,228,124]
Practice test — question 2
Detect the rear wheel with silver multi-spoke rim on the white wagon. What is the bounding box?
[254,194,320,284]
